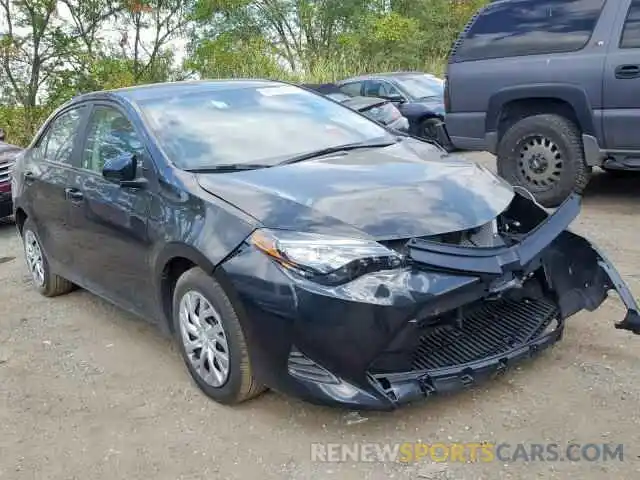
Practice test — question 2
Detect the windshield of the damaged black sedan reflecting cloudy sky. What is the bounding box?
[140,85,393,169]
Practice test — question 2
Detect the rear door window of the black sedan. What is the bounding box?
[38,107,84,165]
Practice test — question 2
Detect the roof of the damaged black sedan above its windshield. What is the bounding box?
[64,79,286,103]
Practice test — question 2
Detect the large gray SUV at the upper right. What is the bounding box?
[445,0,640,207]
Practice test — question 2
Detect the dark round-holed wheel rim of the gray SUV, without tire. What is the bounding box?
[518,135,564,190]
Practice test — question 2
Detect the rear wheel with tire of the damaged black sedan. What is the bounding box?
[22,218,75,297]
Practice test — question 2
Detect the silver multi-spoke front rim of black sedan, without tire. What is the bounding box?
[179,291,229,388]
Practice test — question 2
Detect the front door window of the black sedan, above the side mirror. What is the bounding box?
[82,106,144,173]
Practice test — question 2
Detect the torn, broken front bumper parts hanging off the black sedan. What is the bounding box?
[373,196,640,404]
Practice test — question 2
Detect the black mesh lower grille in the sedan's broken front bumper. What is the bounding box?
[411,298,558,370]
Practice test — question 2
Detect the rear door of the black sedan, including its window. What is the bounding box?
[21,106,87,277]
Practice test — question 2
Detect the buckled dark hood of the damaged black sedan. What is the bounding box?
[198,140,514,240]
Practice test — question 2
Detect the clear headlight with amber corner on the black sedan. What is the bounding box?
[249,229,404,285]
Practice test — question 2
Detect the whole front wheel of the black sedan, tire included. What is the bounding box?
[173,267,265,405]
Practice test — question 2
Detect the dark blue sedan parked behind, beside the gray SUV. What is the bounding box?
[336,72,451,150]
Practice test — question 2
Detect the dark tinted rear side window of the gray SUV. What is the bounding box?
[454,0,605,61]
